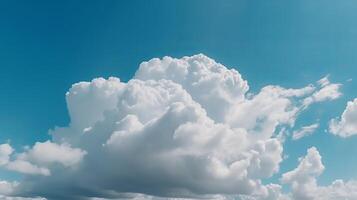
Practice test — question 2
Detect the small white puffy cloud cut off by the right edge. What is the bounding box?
[330,98,357,137]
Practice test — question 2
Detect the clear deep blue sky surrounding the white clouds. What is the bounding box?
[0,0,357,183]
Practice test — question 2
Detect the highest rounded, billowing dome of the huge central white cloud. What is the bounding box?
[134,54,249,122]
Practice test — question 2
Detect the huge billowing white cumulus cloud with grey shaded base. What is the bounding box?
[0,54,339,199]
